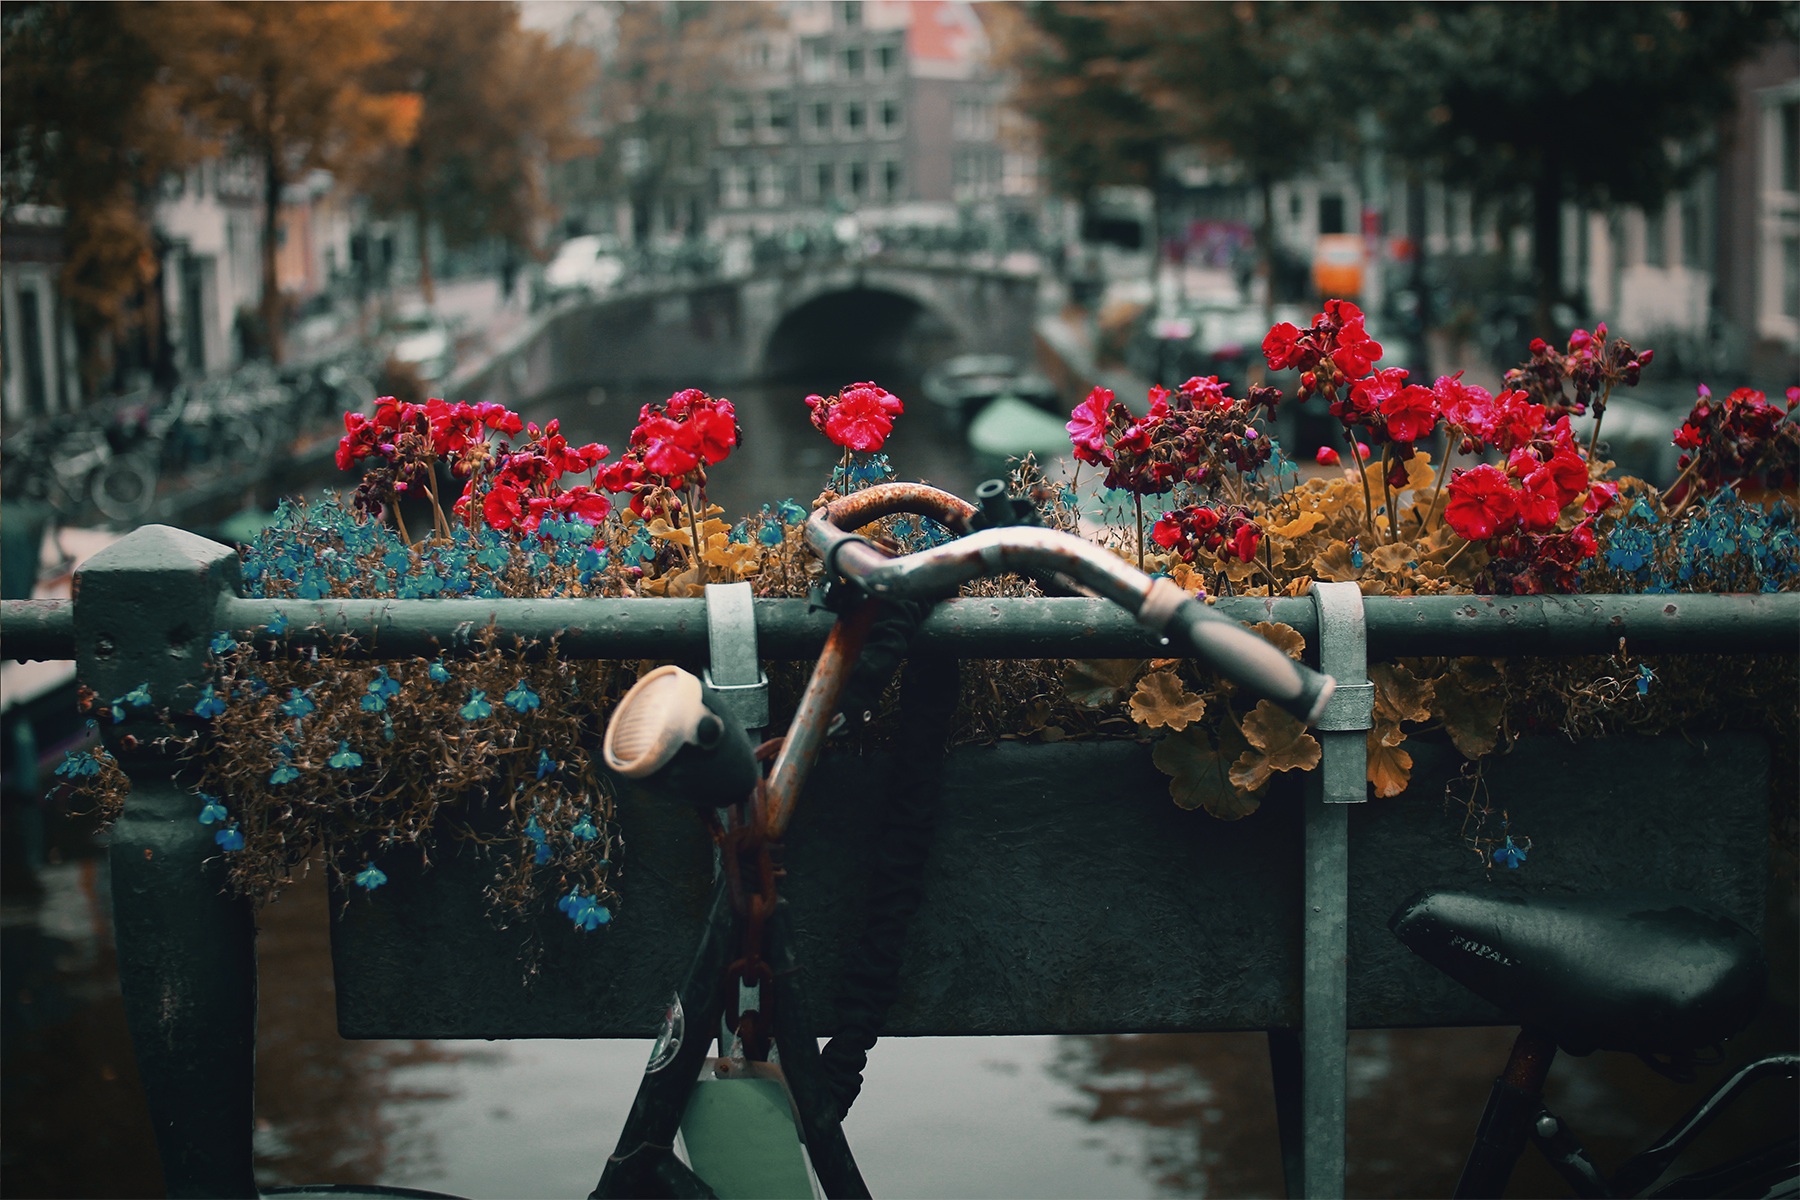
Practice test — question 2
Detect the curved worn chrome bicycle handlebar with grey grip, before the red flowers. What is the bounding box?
[806,484,1337,725]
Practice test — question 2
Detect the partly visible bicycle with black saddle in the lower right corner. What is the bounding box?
[1390,891,1800,1196]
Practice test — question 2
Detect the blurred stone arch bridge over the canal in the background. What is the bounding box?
[454,255,1037,405]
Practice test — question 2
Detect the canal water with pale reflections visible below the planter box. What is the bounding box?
[0,860,1796,1196]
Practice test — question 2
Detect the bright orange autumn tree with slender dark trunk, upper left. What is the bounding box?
[142,0,419,362]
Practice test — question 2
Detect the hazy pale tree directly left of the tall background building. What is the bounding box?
[583,0,774,241]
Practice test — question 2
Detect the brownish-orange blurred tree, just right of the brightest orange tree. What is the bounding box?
[367,0,594,300]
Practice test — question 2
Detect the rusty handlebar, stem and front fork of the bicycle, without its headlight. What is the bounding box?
[592,484,1334,1198]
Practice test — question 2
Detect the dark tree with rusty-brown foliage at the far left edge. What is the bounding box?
[0,2,207,392]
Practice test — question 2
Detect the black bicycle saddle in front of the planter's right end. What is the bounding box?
[1388,892,1768,1054]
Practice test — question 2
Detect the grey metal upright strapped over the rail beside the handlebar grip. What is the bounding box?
[1300,583,1375,1196]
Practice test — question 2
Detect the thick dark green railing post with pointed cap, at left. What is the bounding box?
[76,525,256,1196]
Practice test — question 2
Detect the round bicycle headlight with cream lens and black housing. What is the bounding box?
[601,666,760,808]
